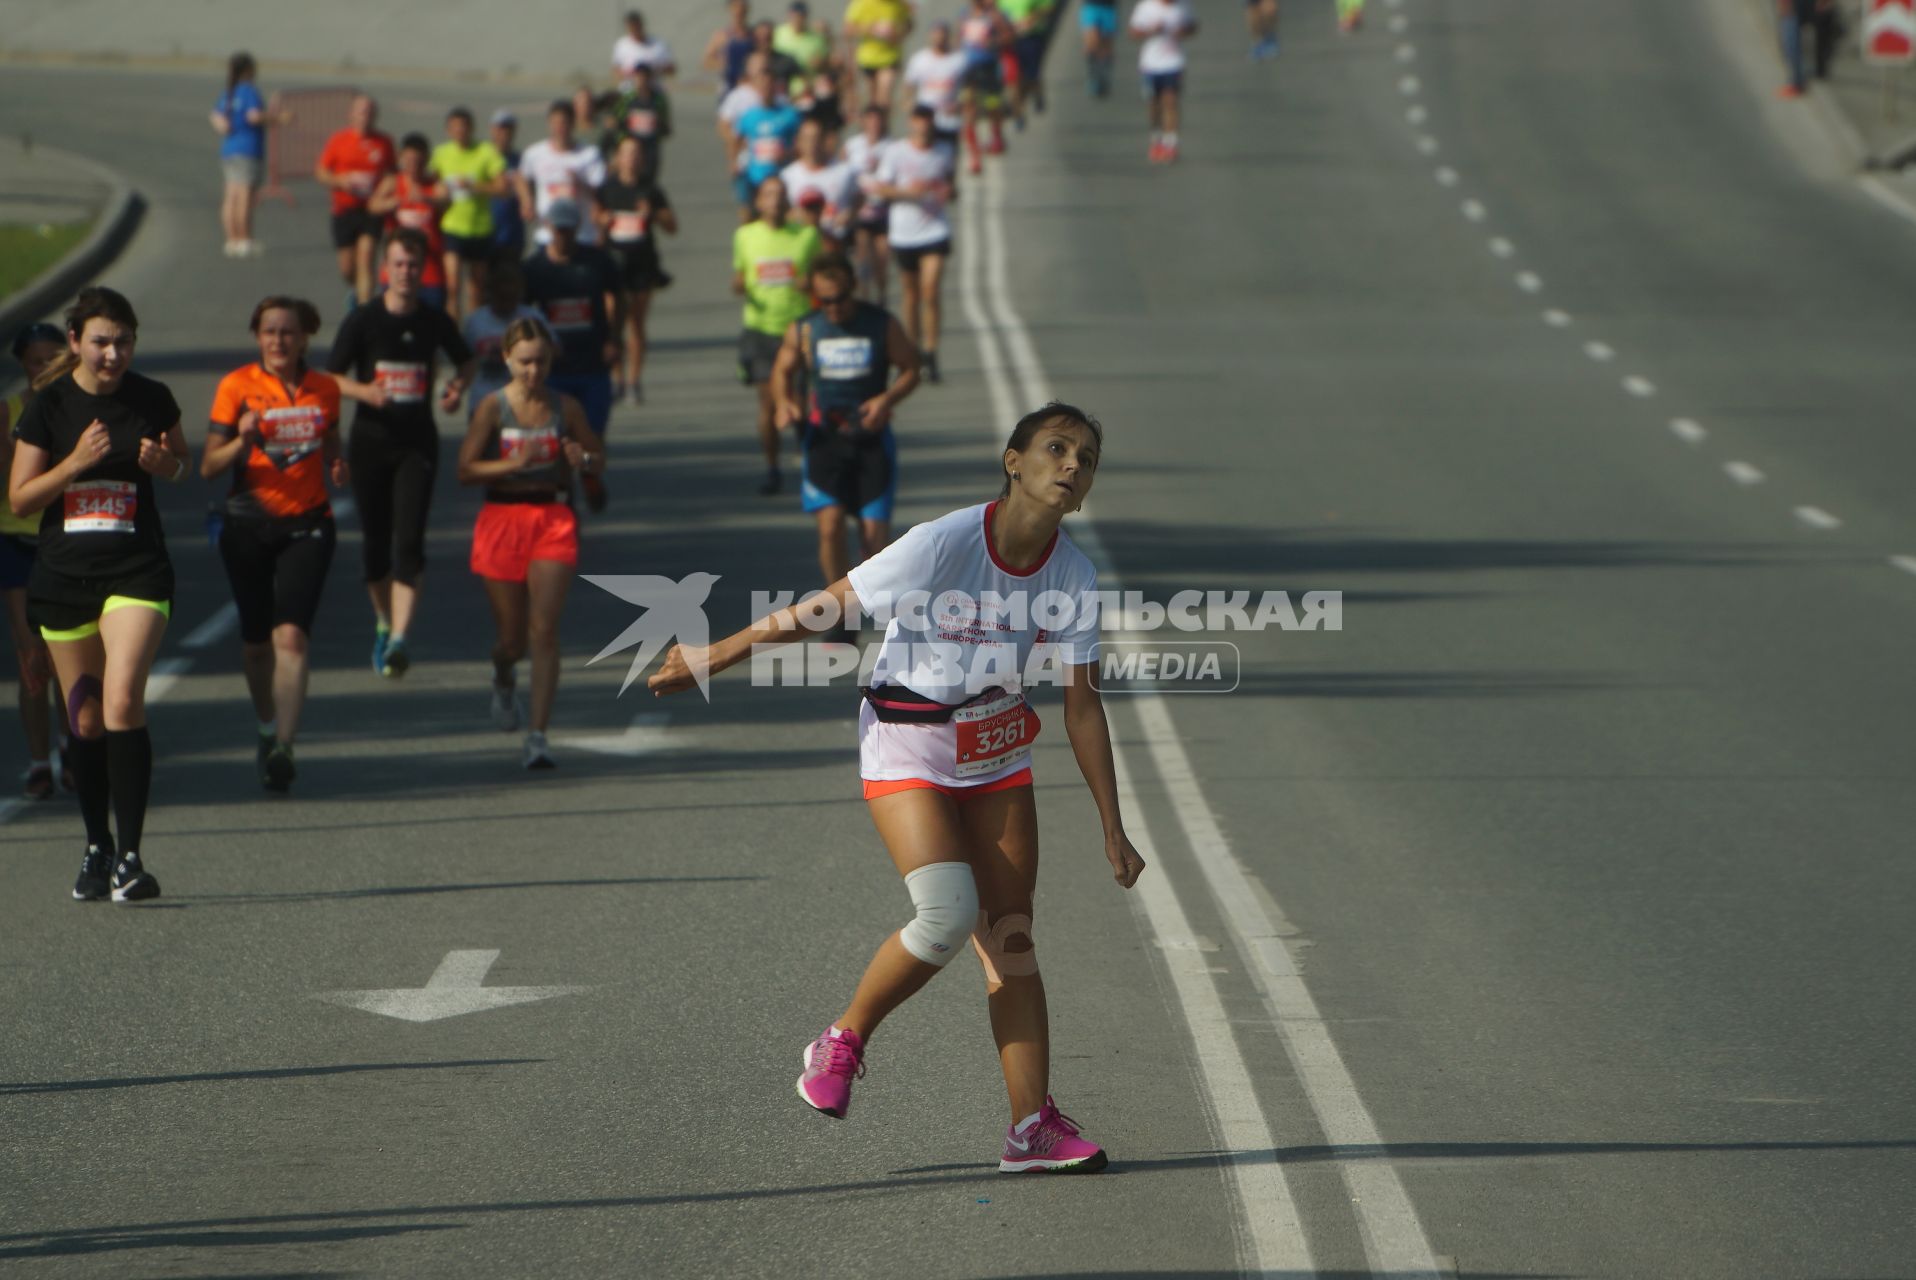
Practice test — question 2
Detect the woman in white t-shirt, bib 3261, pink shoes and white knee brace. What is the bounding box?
[648,404,1144,1173]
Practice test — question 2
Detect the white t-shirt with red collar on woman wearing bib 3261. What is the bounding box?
[849,502,1100,788]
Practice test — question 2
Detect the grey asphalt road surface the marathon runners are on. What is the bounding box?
[0,0,1916,1280]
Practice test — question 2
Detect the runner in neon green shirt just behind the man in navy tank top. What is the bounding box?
[732,174,818,494]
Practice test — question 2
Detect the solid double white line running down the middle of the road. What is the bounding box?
[958,165,1439,1280]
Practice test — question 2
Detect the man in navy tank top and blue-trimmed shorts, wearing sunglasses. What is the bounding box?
[772,253,918,609]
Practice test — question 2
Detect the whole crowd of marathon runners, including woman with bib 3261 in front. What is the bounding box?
[0,0,1360,1171]
